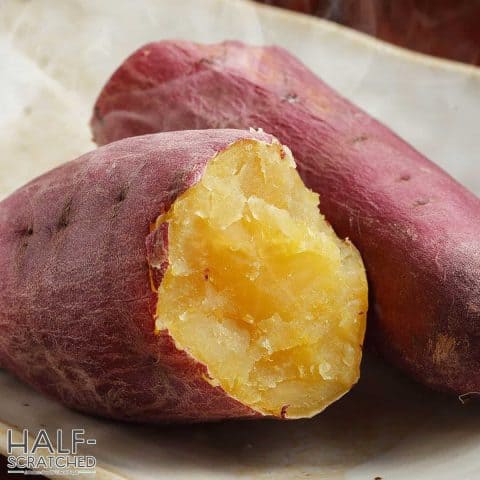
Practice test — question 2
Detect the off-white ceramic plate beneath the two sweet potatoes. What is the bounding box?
[0,0,480,480]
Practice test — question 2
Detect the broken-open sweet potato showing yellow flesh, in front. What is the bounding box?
[0,130,367,422]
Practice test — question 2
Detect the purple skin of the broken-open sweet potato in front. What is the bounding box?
[0,130,272,422]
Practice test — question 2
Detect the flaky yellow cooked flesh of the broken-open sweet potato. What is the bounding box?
[156,140,367,418]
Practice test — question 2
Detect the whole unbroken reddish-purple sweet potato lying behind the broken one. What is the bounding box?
[92,41,480,394]
